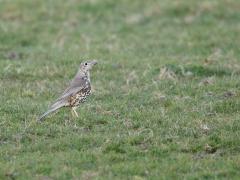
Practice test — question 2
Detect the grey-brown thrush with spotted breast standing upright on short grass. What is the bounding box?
[38,60,97,121]
